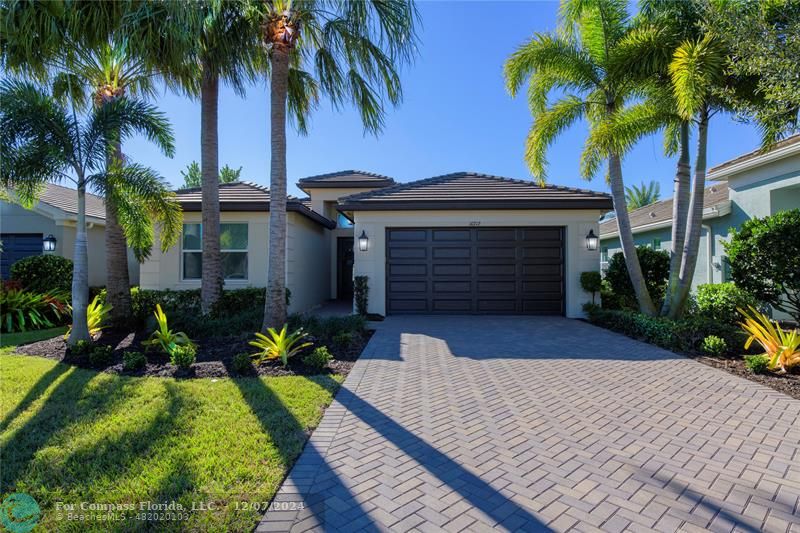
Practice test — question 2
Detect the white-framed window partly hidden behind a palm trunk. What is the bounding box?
[181,222,248,281]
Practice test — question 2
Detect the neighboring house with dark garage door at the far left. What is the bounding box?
[0,183,139,287]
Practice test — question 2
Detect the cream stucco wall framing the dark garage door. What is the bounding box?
[354,210,601,318]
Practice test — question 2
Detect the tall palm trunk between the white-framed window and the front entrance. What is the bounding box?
[261,47,289,330]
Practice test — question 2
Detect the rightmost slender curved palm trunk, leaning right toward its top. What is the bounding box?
[668,107,711,318]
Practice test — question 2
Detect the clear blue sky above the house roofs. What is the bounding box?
[124,1,758,198]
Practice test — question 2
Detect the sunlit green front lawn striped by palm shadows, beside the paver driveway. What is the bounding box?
[0,349,341,531]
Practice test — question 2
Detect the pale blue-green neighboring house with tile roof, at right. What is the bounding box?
[600,135,800,288]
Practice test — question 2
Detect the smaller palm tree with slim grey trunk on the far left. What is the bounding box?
[0,80,181,345]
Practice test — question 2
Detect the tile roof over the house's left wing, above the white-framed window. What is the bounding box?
[175,181,336,228]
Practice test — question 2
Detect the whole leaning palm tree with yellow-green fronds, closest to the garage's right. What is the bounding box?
[505,0,656,315]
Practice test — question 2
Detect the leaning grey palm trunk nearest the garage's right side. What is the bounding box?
[608,154,656,316]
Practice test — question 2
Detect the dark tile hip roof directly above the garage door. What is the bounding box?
[339,172,612,211]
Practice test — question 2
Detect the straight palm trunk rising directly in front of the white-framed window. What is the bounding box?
[200,61,222,314]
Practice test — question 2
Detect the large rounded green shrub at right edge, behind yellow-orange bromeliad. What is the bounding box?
[725,209,800,322]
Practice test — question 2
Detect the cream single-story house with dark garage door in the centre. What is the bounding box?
[140,171,611,317]
